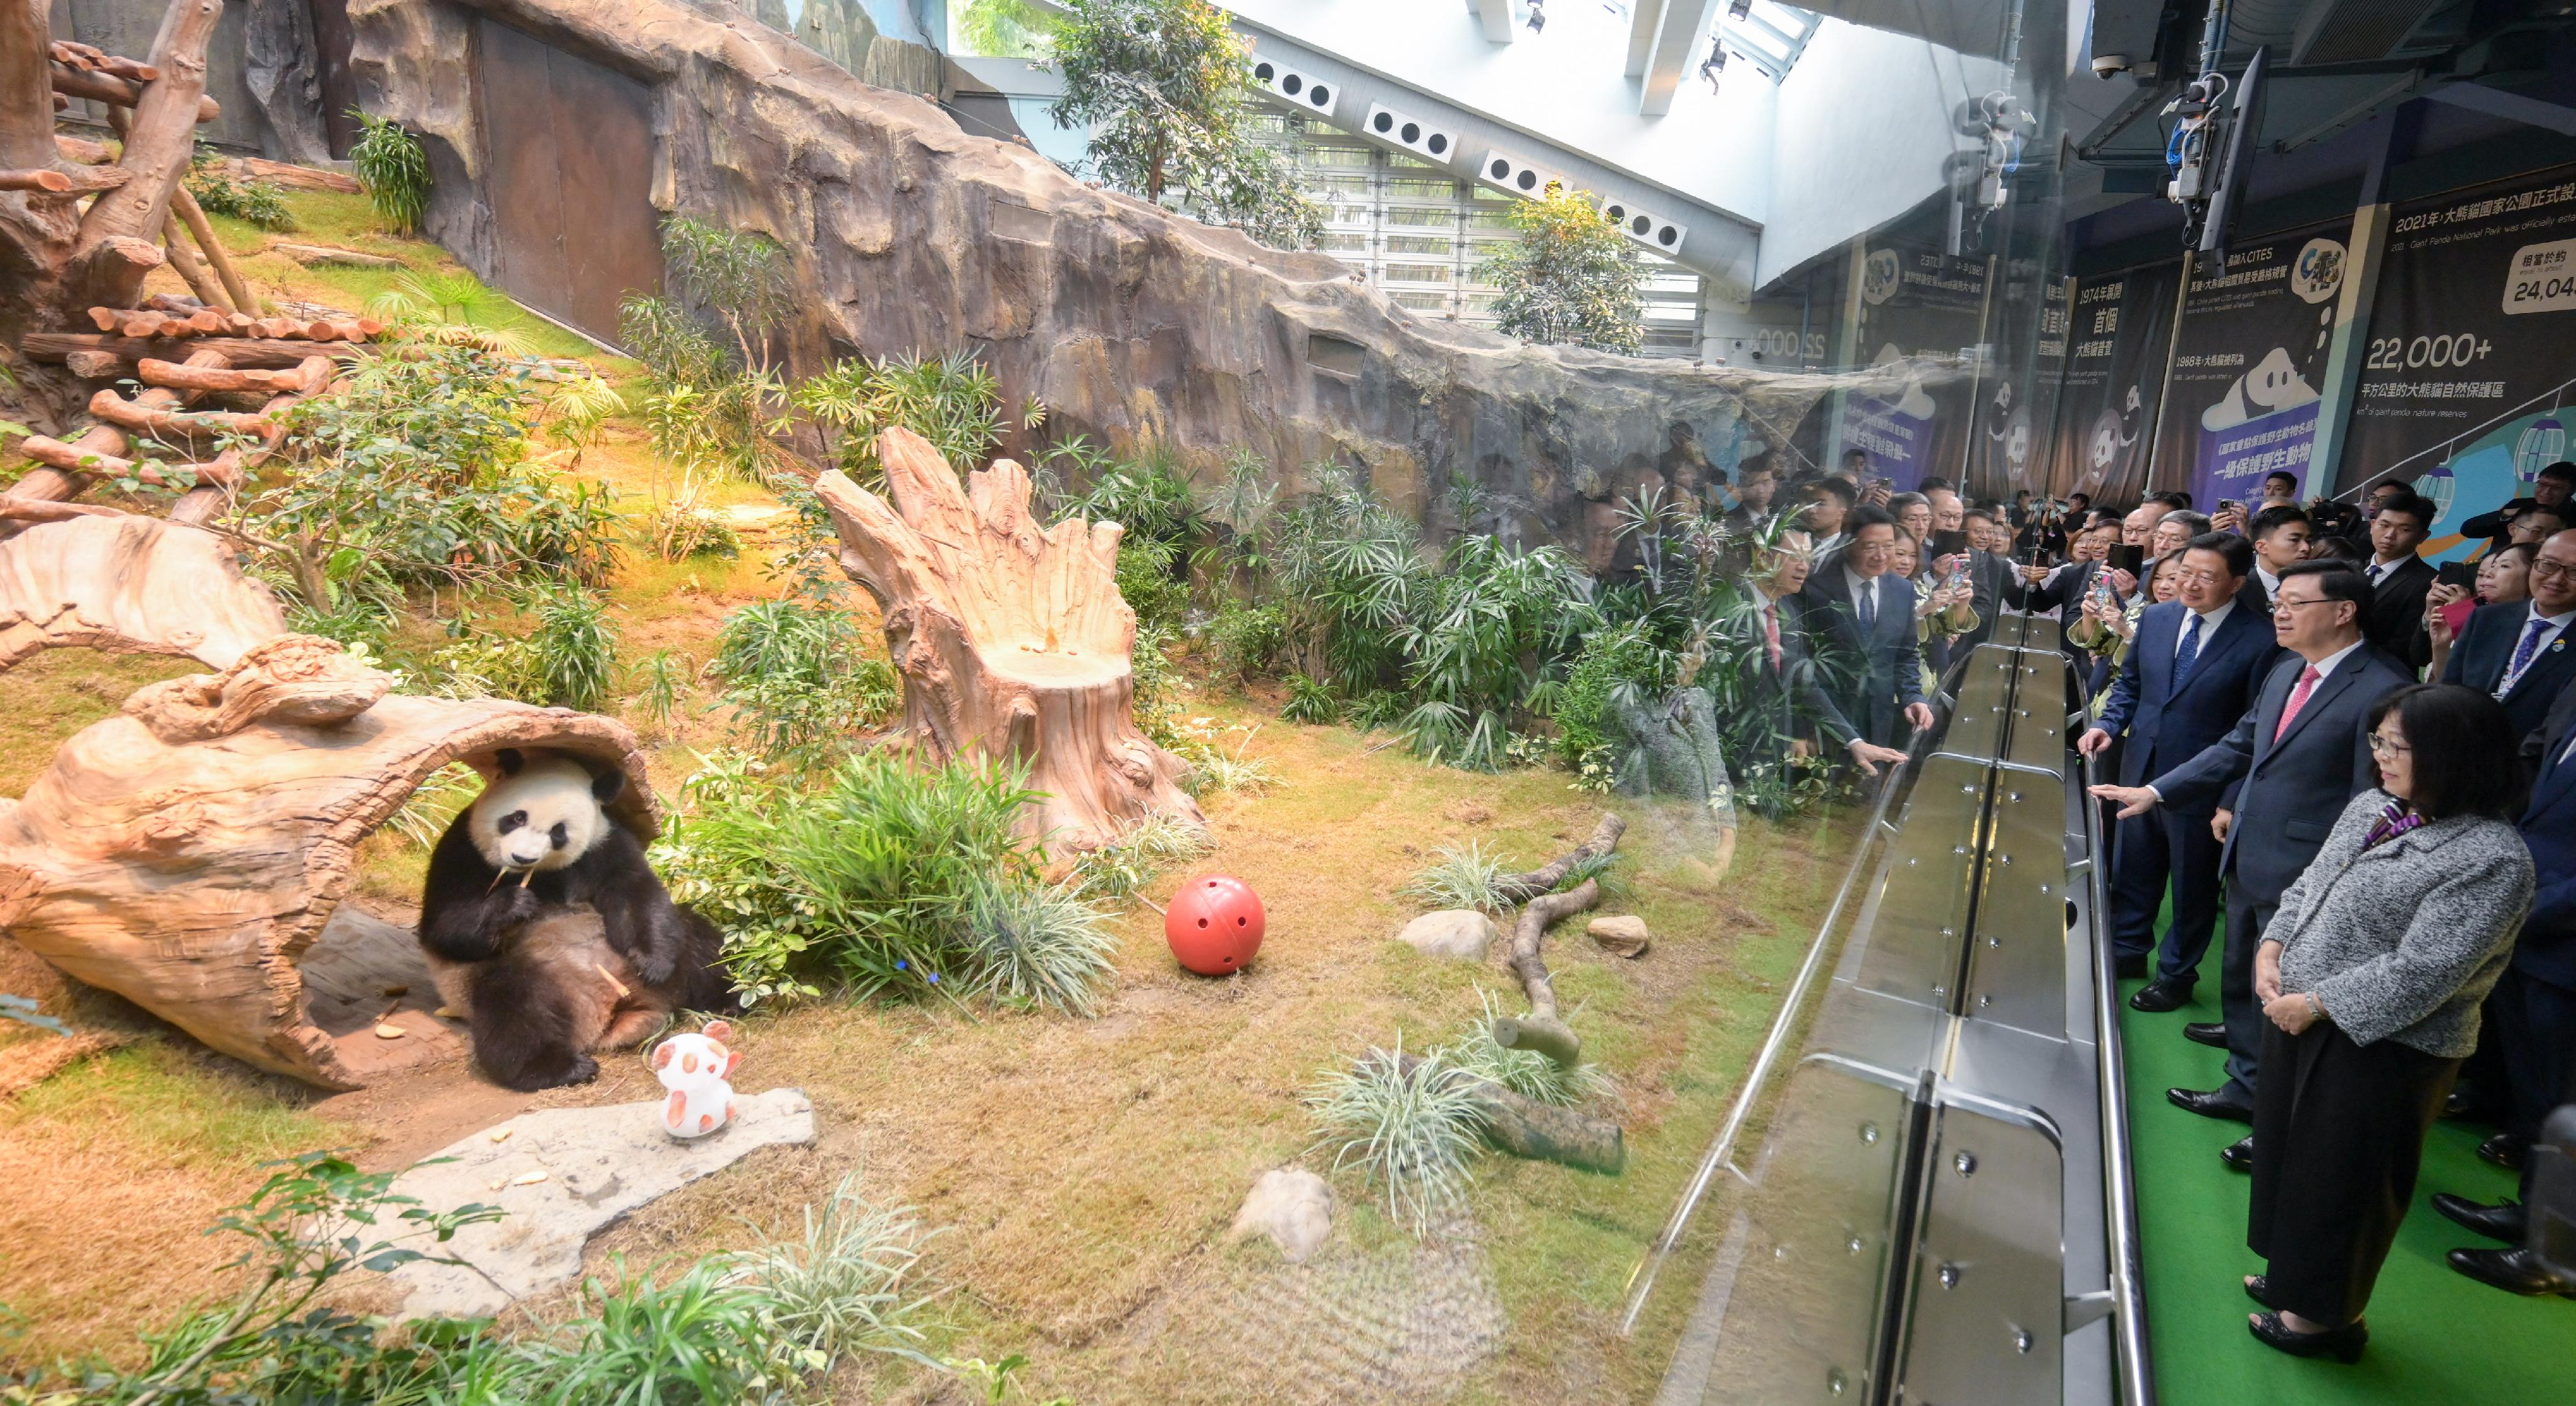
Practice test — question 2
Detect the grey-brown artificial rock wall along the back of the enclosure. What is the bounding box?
[348,0,1834,567]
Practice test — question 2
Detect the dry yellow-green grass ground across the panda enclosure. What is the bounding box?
[0,182,1850,1406]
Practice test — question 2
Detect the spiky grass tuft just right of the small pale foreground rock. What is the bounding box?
[1306,1032,1481,1236]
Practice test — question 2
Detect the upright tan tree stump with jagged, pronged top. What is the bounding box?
[814,430,1206,850]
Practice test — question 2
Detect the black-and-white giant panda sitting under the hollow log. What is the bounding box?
[420,749,734,1089]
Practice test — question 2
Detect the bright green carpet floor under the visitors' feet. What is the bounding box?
[2120,963,2576,1406]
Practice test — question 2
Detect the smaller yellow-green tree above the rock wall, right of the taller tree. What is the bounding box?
[1476,188,1646,356]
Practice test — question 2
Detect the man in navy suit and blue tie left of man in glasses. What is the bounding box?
[2076,533,2277,1012]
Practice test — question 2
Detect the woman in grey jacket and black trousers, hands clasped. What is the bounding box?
[2246,685,2532,1362]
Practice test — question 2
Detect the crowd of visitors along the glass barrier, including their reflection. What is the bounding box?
[1726,459,2576,1362]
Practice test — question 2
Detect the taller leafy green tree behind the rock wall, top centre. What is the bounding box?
[1051,0,1324,250]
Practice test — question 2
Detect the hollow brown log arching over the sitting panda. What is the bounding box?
[0,633,657,1089]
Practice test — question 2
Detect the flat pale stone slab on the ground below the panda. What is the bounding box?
[389,1089,814,1318]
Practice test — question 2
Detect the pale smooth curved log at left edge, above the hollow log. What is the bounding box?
[0,505,286,670]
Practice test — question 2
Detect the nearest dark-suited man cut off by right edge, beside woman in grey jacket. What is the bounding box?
[2432,669,2576,1295]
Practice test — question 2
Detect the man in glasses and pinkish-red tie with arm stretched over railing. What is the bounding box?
[2094,562,2414,1123]
